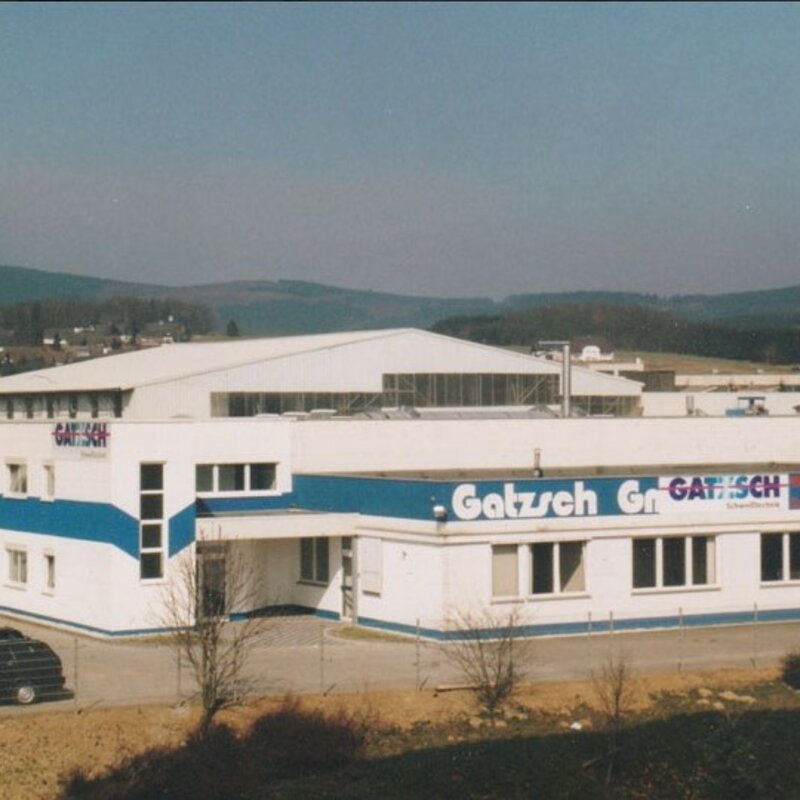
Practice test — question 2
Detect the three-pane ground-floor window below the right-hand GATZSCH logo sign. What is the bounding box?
[632,536,716,589]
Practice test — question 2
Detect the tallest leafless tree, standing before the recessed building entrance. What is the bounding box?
[159,539,267,734]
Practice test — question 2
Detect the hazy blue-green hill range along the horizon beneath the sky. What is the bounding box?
[0,266,800,335]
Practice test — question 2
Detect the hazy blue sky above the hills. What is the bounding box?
[0,3,800,297]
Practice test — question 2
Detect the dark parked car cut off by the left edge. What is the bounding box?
[0,628,64,705]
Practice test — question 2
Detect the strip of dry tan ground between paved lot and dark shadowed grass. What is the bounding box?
[0,669,777,800]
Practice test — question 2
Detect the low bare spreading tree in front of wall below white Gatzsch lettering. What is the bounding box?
[444,610,530,723]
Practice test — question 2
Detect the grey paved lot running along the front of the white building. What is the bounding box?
[0,616,800,713]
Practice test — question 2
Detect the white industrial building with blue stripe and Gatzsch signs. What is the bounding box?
[0,330,800,637]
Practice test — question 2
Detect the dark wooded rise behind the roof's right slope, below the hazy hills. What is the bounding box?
[432,304,800,364]
